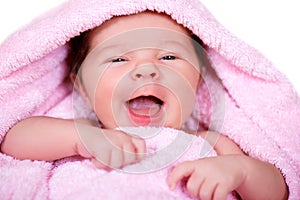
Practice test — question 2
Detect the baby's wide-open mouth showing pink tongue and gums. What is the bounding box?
[128,96,161,117]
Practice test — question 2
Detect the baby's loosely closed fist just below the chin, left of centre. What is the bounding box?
[77,125,146,169]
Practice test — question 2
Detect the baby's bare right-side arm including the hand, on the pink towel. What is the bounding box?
[169,132,288,200]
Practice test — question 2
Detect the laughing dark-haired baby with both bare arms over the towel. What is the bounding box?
[1,12,287,199]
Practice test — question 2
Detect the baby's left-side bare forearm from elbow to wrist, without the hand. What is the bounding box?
[1,117,77,161]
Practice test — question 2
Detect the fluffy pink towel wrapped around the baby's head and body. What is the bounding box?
[0,0,300,199]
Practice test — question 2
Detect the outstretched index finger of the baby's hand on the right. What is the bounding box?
[168,162,194,190]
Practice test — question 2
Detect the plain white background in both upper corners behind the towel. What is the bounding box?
[0,0,300,94]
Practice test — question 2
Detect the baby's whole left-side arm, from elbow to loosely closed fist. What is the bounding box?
[1,117,145,168]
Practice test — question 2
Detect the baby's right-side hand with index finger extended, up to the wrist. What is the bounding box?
[169,155,246,200]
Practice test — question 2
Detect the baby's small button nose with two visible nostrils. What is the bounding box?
[131,64,159,80]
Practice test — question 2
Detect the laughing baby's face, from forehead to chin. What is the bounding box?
[80,12,200,128]
